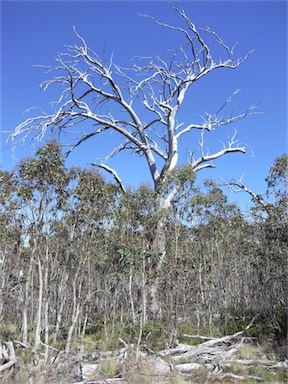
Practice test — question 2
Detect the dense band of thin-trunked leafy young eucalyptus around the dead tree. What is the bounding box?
[0,141,288,360]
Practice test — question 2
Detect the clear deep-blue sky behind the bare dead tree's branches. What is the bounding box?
[0,0,287,210]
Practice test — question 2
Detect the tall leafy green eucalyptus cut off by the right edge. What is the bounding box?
[249,154,288,333]
